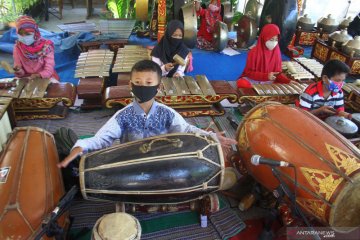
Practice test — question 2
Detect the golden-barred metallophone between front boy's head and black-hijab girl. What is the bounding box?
[112,45,151,85]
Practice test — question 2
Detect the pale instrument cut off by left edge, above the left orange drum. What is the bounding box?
[0,97,16,153]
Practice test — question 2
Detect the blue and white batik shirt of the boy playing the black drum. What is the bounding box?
[74,101,217,153]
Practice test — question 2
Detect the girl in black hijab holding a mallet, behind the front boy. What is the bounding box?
[151,20,190,77]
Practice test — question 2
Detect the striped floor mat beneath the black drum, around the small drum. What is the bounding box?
[69,196,245,240]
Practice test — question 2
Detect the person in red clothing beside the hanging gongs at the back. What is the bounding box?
[195,0,221,50]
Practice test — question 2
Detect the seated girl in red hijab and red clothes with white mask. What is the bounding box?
[237,24,290,88]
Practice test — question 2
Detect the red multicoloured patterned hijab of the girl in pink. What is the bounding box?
[15,16,54,60]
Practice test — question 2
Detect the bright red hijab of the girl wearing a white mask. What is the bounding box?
[241,24,281,77]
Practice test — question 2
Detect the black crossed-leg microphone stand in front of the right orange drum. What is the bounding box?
[259,167,321,240]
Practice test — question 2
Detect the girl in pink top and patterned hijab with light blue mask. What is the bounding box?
[13,16,59,82]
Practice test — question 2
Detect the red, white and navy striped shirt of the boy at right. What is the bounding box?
[296,81,345,112]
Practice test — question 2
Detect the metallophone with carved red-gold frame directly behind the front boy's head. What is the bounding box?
[104,75,238,117]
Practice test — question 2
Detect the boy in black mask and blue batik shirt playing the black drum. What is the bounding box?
[58,60,236,168]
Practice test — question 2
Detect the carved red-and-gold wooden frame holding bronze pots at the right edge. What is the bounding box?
[311,38,360,75]
